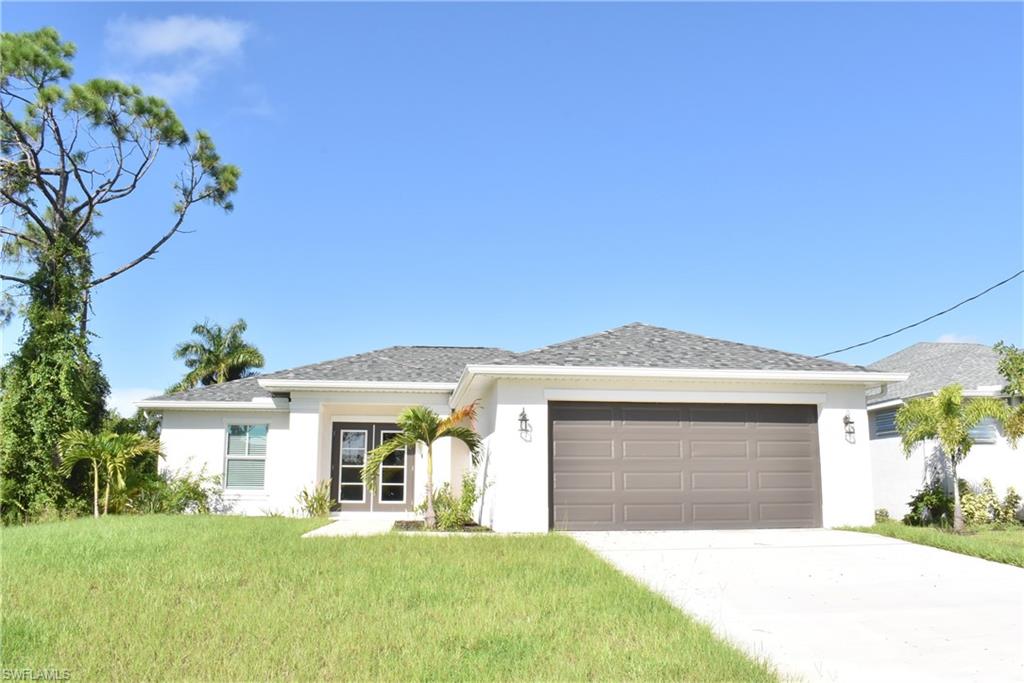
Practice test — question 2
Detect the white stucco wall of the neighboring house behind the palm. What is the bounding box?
[870,421,1024,519]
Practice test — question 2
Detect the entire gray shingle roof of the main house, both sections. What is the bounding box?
[150,323,864,400]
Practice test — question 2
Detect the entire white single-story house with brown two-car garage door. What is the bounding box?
[139,324,906,531]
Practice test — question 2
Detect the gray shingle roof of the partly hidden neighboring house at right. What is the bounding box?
[867,342,1006,404]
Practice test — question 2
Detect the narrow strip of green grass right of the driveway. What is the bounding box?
[851,521,1024,567]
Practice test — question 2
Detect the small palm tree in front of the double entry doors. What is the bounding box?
[362,402,480,528]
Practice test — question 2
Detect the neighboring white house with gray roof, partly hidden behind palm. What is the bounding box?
[867,342,1024,519]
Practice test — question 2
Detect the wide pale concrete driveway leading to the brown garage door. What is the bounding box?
[572,529,1024,682]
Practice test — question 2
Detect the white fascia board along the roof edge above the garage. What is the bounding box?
[451,365,909,405]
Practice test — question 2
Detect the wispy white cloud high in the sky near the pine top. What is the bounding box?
[105,14,250,99]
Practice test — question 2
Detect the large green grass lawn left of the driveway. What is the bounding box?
[0,516,774,681]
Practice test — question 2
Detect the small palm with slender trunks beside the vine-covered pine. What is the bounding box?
[60,429,161,517]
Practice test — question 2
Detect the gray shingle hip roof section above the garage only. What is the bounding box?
[496,323,864,372]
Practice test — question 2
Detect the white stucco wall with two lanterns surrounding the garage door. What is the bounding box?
[471,379,873,531]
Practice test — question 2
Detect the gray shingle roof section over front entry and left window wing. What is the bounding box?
[150,346,512,400]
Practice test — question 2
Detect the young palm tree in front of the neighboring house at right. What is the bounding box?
[896,384,1008,532]
